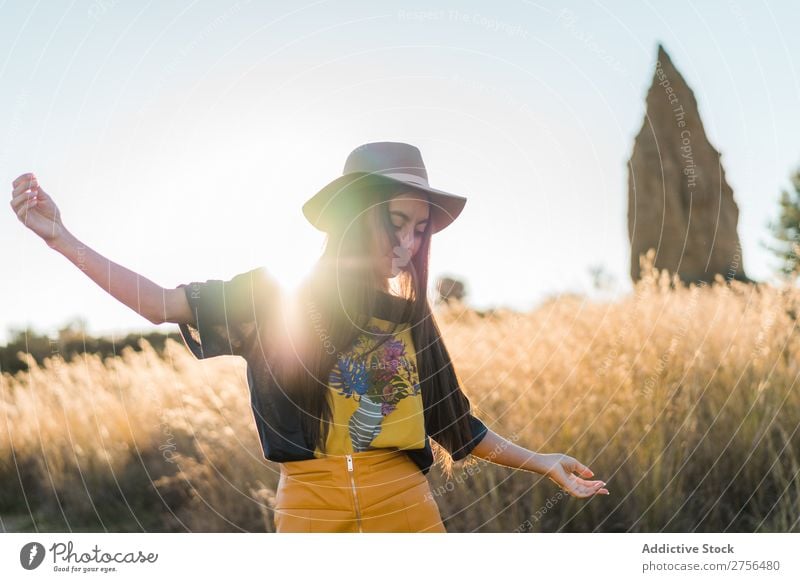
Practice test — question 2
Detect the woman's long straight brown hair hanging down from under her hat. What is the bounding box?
[264,182,472,480]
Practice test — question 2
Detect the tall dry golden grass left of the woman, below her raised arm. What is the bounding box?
[0,340,277,531]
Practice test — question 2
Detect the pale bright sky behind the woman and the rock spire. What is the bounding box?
[0,0,800,341]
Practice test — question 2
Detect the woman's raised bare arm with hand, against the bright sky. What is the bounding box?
[11,173,194,324]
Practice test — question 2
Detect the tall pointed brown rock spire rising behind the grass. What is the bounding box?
[628,44,749,283]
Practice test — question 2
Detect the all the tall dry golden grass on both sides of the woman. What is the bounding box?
[0,260,800,532]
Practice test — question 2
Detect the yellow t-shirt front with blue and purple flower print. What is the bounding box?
[314,317,426,457]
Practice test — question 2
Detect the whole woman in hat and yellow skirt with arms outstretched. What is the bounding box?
[11,142,608,532]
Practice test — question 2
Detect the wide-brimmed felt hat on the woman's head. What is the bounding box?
[303,141,467,233]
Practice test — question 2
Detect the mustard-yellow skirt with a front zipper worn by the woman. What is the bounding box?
[274,449,447,533]
